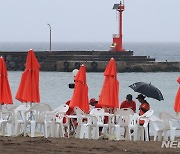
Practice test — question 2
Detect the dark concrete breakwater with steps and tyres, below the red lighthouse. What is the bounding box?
[0,51,180,72]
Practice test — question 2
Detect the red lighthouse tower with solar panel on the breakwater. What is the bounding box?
[111,1,124,52]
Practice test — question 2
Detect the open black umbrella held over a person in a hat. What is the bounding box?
[129,82,164,101]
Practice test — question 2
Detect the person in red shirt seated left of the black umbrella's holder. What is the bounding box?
[120,94,136,112]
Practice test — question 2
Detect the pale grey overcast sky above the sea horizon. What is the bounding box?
[0,0,180,42]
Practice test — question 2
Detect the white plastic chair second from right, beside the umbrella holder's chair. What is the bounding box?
[150,115,164,141]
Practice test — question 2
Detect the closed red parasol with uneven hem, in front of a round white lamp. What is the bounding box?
[69,65,90,113]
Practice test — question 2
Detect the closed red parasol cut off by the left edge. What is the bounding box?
[0,57,13,104]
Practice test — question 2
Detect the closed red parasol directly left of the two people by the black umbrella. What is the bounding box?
[98,58,119,108]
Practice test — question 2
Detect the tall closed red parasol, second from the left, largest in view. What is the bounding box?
[16,49,40,103]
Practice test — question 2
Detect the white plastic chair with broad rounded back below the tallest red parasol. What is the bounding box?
[24,103,52,137]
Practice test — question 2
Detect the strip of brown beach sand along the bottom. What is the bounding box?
[0,137,180,154]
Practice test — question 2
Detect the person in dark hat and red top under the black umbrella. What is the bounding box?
[136,94,150,140]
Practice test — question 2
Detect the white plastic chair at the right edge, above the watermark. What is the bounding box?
[159,112,180,141]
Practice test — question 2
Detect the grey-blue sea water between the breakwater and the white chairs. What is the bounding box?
[8,71,180,115]
